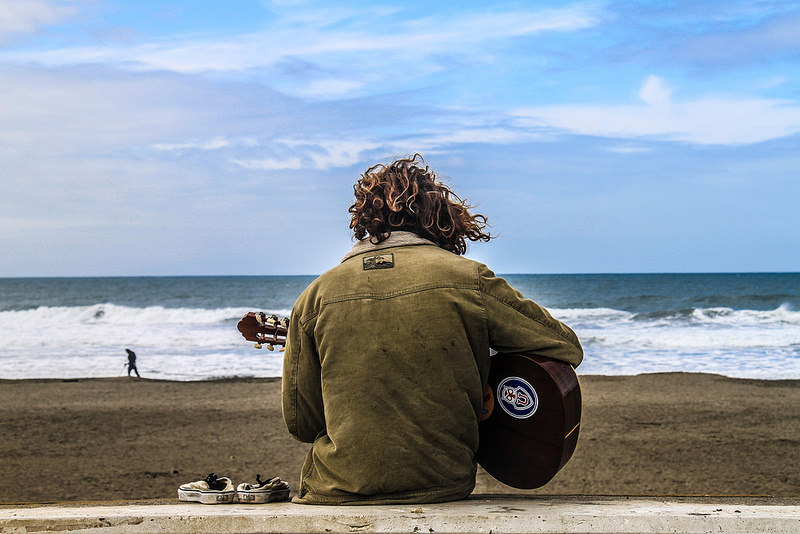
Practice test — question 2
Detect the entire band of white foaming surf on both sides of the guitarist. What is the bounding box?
[0,304,800,380]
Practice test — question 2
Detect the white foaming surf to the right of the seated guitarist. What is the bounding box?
[552,305,800,379]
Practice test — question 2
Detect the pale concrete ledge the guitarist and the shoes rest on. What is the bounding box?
[0,496,800,534]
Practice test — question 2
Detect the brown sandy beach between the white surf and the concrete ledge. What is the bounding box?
[0,373,800,503]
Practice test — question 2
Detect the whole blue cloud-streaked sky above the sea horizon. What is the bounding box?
[0,0,800,276]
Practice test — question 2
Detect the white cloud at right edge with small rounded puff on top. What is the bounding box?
[513,77,800,145]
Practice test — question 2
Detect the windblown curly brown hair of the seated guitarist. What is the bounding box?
[348,154,492,254]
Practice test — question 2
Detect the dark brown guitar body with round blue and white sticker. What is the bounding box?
[477,353,581,489]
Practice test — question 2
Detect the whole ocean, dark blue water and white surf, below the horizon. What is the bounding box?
[0,273,800,380]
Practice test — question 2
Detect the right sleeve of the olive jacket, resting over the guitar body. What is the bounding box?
[478,265,583,367]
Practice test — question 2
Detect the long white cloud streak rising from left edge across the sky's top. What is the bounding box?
[0,4,598,98]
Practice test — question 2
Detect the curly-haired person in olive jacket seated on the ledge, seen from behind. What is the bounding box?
[282,155,583,504]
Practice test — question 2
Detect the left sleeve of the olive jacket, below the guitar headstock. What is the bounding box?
[281,297,325,443]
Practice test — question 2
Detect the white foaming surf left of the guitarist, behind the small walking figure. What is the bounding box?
[0,304,289,380]
